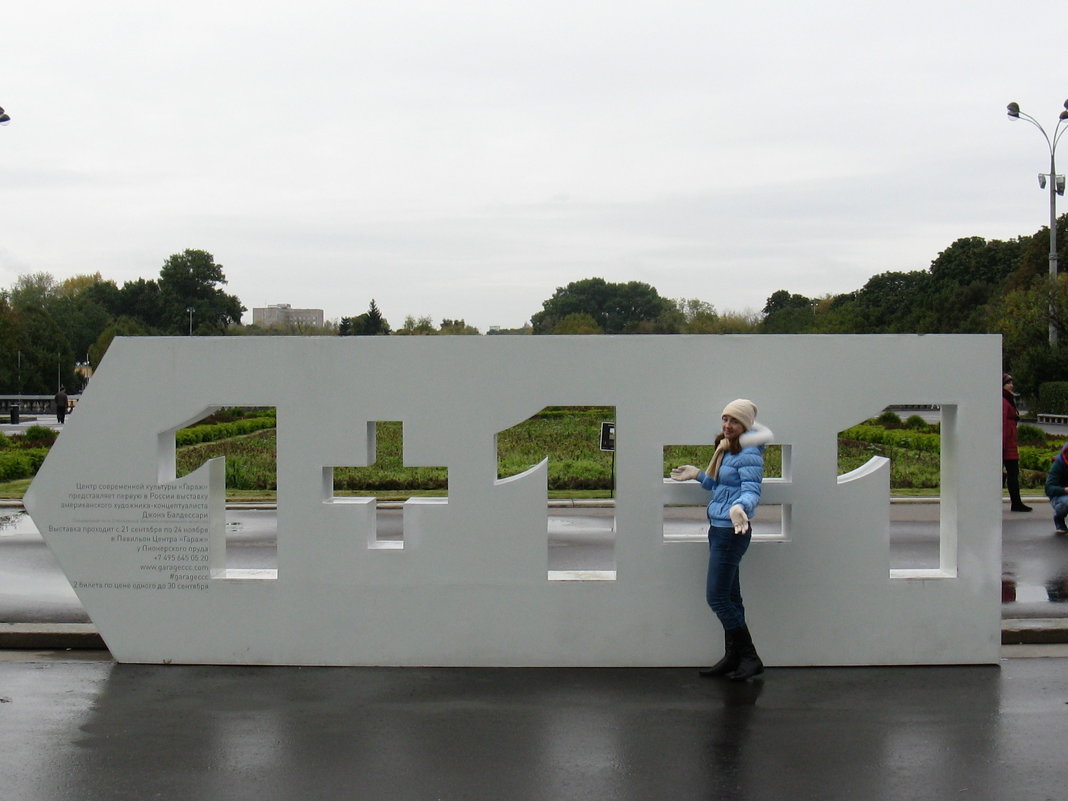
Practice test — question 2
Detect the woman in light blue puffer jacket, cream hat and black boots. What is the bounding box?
[671,398,773,681]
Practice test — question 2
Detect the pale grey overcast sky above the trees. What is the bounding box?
[0,0,1068,330]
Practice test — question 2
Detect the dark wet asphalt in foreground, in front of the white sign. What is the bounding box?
[0,651,1068,801]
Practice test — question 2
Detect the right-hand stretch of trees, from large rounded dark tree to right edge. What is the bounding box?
[531,220,1068,397]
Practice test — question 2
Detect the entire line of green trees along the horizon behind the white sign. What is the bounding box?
[6,215,1068,396]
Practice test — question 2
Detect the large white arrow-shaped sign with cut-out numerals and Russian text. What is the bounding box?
[26,335,1001,665]
